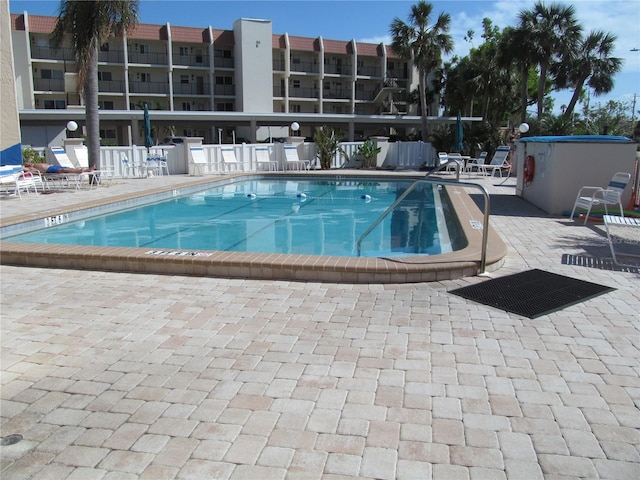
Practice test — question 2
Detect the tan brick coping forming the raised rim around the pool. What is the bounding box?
[0,171,507,283]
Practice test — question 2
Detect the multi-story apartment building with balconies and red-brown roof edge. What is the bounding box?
[11,12,437,146]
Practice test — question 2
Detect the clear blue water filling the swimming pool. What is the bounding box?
[5,177,466,257]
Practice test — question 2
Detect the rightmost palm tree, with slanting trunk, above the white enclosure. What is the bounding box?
[558,31,622,118]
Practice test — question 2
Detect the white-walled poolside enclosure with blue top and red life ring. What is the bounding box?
[516,135,636,215]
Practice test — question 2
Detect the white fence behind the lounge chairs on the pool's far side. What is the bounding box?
[45,142,437,177]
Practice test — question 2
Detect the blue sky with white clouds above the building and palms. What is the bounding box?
[9,0,640,118]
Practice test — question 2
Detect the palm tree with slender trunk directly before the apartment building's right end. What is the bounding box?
[390,0,453,140]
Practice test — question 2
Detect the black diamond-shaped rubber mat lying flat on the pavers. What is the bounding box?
[449,269,615,318]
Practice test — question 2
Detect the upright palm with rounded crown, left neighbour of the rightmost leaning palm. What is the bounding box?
[519,2,582,118]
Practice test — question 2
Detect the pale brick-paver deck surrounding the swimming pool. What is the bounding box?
[0,171,640,480]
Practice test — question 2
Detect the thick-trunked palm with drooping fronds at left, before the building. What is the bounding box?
[51,0,139,166]
